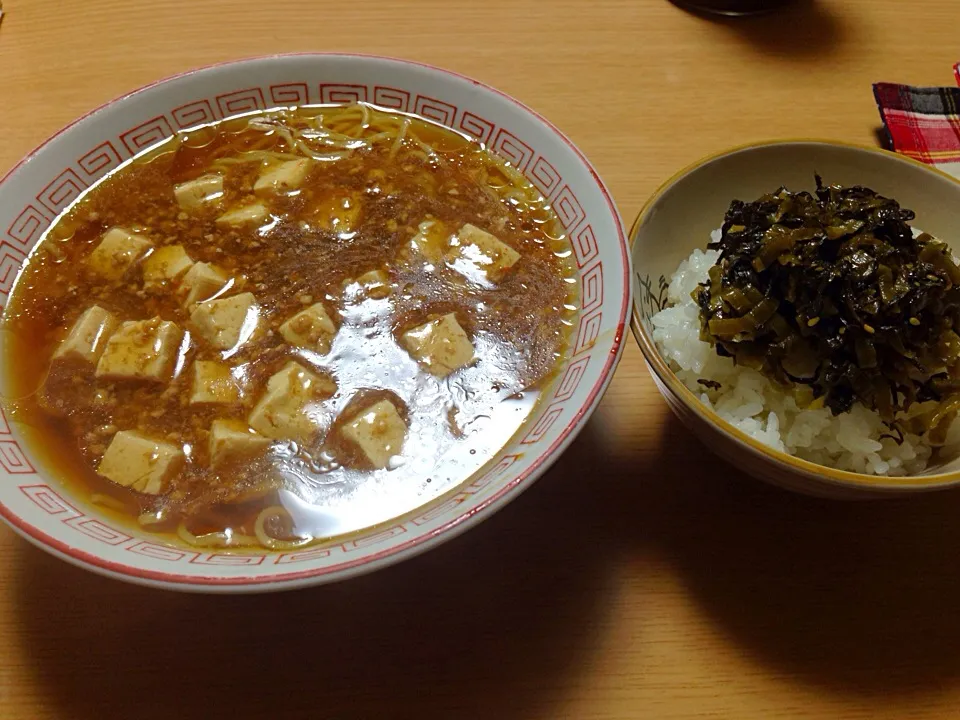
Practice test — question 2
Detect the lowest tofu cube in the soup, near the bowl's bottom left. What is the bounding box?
[97,430,184,495]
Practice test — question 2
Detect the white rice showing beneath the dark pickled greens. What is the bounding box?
[651,230,960,475]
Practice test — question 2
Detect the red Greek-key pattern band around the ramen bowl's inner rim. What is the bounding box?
[0,57,626,584]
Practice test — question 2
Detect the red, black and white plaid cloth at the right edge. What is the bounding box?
[873,63,960,177]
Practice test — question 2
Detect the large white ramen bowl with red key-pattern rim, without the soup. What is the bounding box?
[0,54,630,592]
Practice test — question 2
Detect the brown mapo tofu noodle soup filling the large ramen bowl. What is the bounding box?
[5,105,576,549]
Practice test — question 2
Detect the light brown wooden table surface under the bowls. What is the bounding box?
[0,0,960,720]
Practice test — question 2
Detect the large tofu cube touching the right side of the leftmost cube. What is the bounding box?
[96,317,183,381]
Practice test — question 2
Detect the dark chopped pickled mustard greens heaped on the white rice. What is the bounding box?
[693,176,960,444]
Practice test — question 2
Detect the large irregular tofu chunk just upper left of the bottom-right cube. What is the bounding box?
[248,361,337,442]
